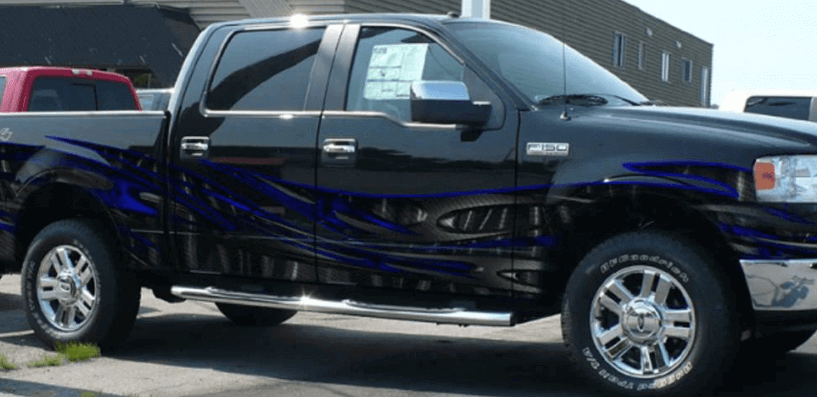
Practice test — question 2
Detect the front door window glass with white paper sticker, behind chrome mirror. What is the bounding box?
[346,28,470,121]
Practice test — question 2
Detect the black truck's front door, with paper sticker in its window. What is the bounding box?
[316,24,518,295]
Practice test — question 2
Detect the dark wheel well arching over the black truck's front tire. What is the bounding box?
[559,195,754,327]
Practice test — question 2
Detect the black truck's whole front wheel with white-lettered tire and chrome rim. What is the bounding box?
[562,231,740,396]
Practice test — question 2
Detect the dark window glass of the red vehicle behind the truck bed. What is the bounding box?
[28,77,138,112]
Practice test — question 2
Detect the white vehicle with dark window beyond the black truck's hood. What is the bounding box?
[720,90,817,122]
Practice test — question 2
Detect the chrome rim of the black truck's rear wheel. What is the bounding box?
[37,245,99,331]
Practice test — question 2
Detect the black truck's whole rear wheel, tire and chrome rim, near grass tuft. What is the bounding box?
[21,219,140,351]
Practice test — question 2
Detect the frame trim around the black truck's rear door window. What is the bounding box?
[199,23,334,119]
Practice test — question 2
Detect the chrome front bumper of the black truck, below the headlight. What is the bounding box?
[740,259,817,311]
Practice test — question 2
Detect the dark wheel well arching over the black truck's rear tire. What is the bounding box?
[15,183,117,271]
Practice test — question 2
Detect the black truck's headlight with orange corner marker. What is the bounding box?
[754,155,817,203]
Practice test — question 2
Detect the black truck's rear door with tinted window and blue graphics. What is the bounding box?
[170,25,342,282]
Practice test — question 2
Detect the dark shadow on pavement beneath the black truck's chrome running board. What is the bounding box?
[108,315,596,396]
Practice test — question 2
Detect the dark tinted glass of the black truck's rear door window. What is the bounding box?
[207,29,323,110]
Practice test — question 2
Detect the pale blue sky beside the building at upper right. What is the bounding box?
[624,0,817,104]
